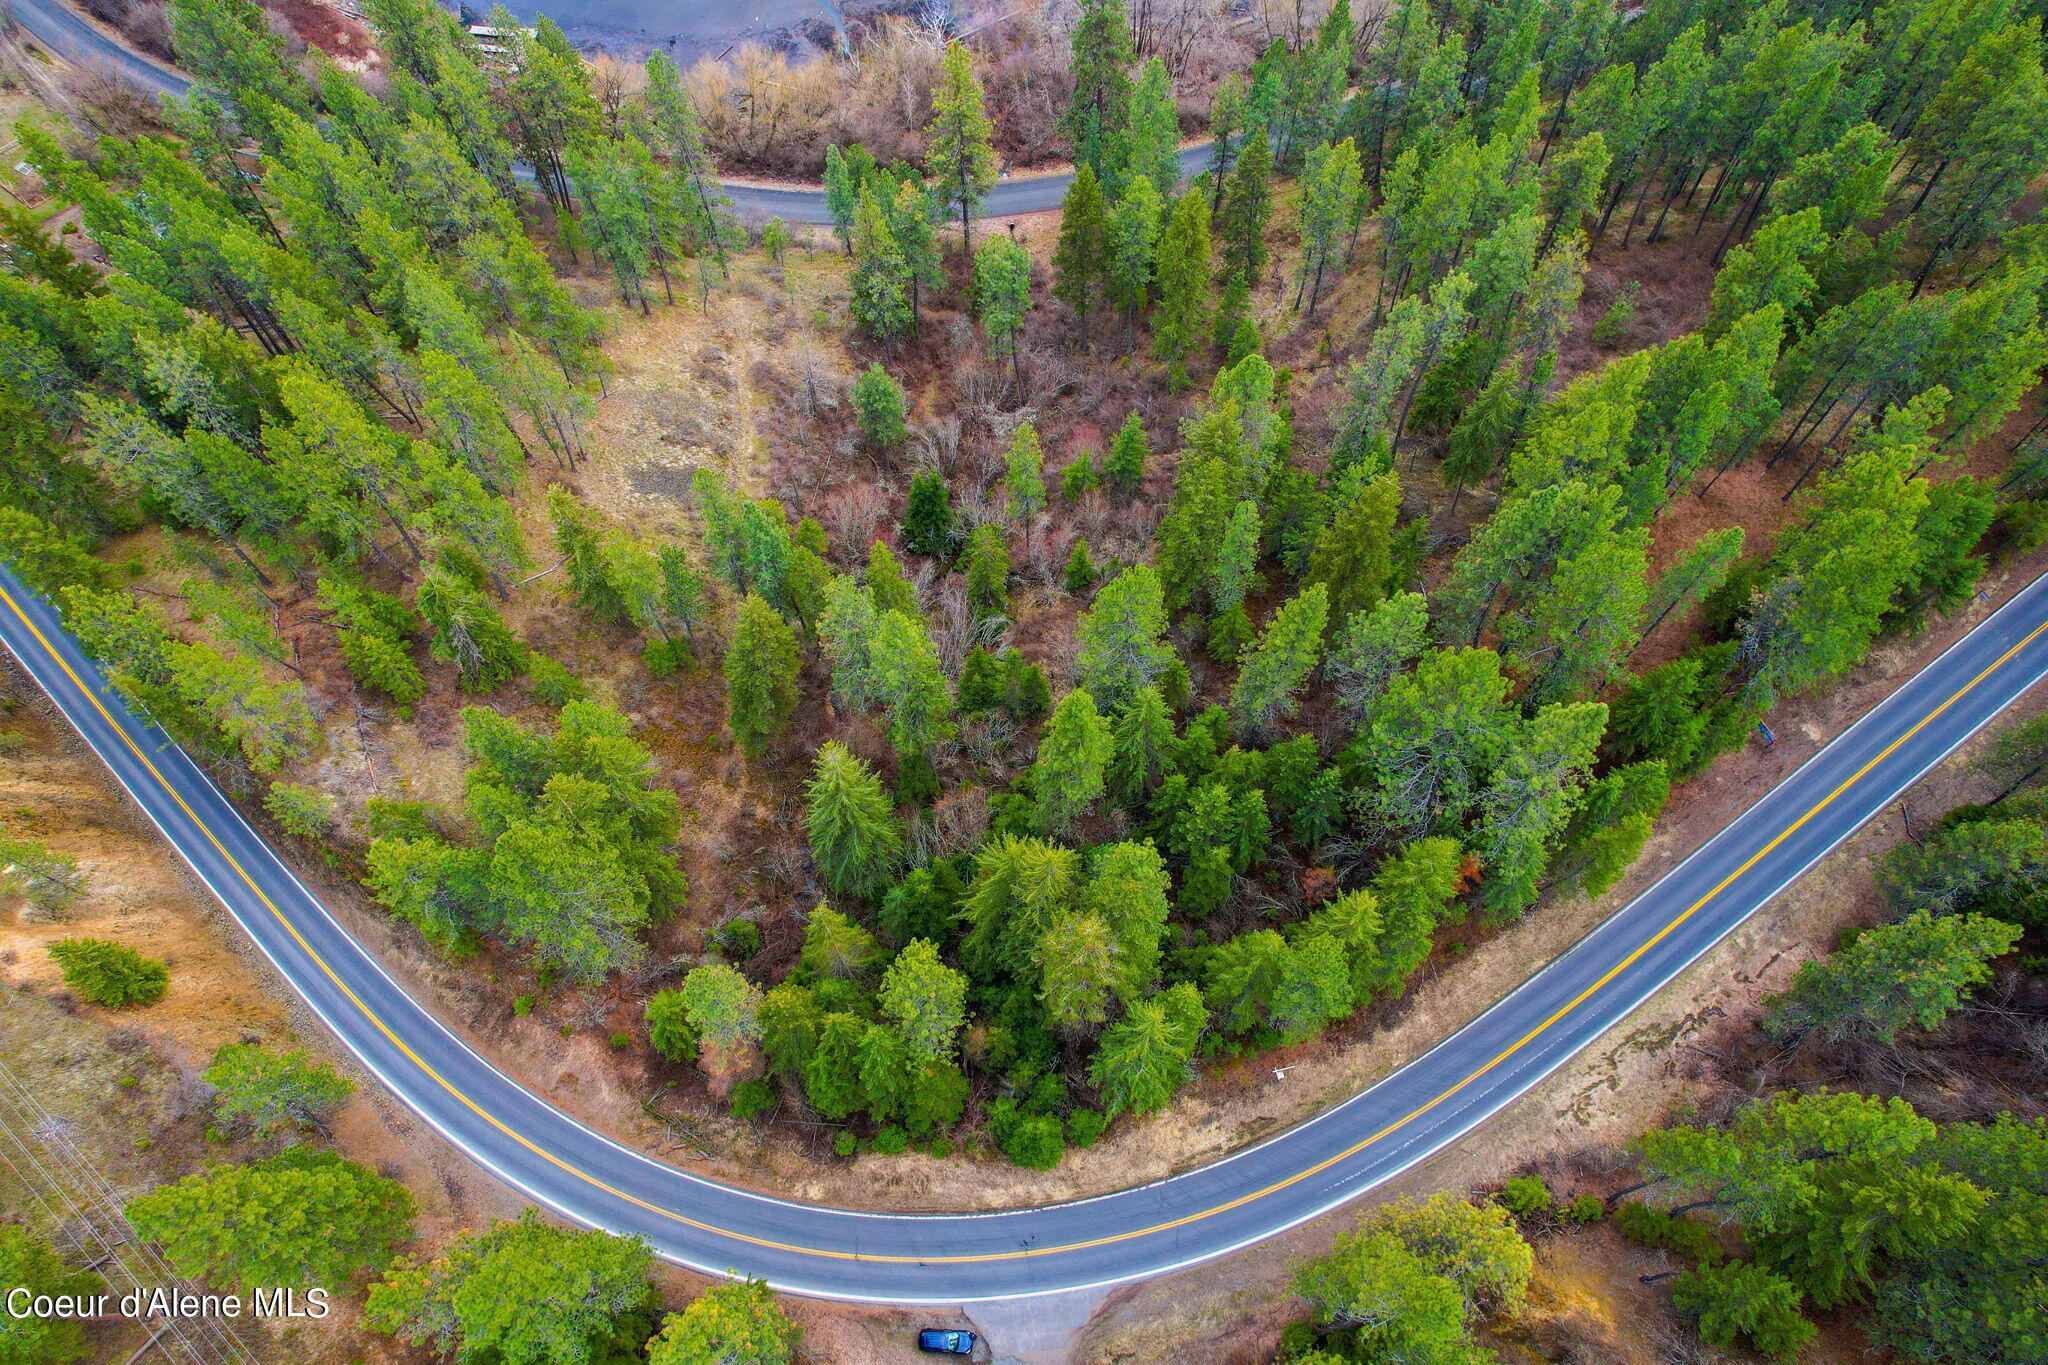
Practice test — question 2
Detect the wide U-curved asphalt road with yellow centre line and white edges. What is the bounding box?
[16,569,2048,1304]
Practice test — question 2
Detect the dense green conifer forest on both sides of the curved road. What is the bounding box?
[0,0,2048,1361]
